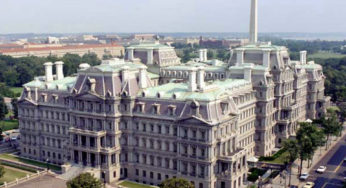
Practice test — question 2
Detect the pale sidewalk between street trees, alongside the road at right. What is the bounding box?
[272,130,346,188]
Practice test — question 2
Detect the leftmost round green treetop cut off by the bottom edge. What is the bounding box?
[66,173,102,188]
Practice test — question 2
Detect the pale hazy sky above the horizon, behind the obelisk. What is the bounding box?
[0,0,346,34]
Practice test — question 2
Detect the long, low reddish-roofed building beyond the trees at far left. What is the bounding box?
[0,44,124,58]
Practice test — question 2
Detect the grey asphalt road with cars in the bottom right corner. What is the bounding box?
[308,135,346,188]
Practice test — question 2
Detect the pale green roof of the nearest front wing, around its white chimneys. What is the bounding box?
[138,79,250,101]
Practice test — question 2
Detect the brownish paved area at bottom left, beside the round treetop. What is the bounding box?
[13,174,66,188]
